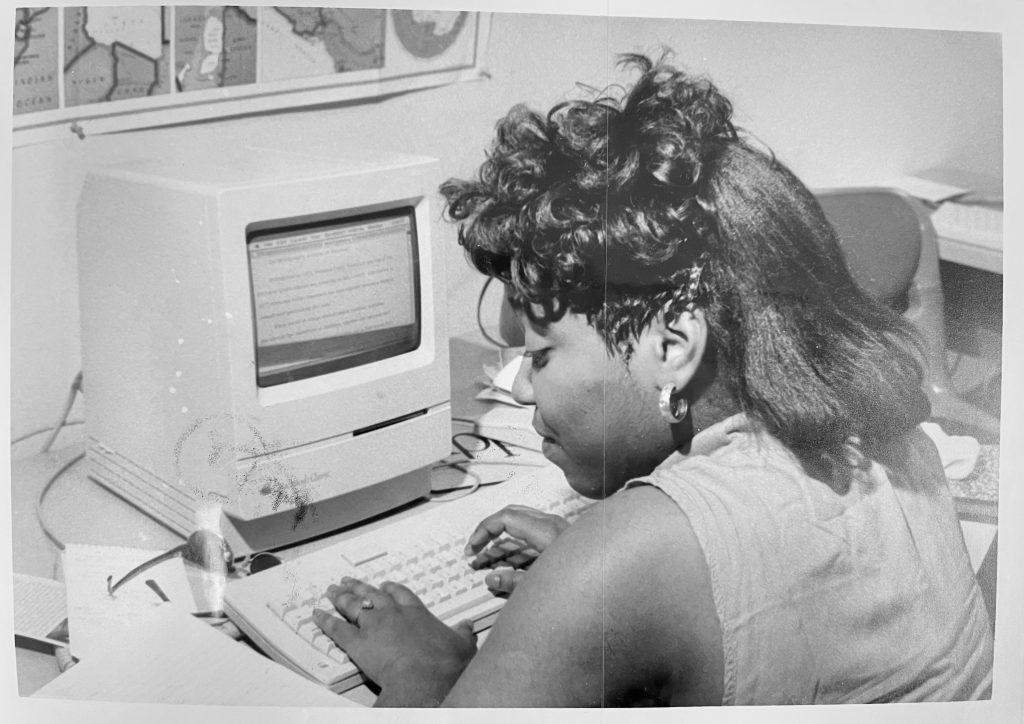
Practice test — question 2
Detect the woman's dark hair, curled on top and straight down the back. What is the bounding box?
[441,55,930,487]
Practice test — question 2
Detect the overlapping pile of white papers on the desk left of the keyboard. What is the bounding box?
[35,545,354,707]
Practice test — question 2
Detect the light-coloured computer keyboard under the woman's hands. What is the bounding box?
[224,466,589,693]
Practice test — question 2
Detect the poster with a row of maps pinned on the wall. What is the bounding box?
[13,5,490,145]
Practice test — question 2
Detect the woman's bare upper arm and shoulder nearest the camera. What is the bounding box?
[444,486,722,707]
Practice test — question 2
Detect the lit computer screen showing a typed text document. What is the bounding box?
[247,207,422,387]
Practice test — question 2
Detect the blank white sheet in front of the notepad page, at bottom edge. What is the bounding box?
[34,604,356,707]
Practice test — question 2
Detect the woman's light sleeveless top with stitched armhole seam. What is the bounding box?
[630,415,992,705]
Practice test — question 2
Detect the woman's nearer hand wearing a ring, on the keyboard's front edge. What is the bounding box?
[313,578,476,707]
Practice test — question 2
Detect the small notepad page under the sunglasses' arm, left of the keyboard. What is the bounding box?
[63,544,197,661]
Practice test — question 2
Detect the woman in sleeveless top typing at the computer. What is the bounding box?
[318,56,992,707]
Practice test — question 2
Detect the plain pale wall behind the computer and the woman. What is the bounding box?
[10,9,1002,436]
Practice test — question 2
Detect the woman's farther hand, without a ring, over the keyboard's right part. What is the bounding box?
[466,505,569,593]
